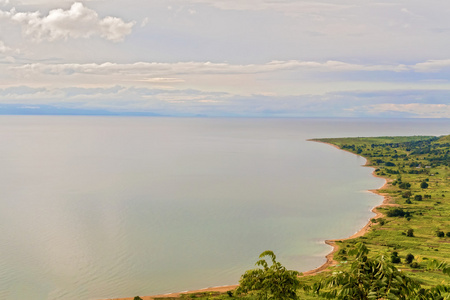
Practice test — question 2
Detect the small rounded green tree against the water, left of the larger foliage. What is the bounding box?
[237,250,300,300]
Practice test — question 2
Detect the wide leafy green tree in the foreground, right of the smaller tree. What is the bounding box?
[314,243,420,300]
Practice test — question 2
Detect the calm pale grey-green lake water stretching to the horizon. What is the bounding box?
[0,116,450,300]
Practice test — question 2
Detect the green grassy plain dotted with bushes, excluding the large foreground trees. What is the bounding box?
[132,135,450,299]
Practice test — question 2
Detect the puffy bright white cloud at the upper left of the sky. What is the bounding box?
[0,2,135,42]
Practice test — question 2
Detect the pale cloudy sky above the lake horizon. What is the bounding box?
[0,0,450,118]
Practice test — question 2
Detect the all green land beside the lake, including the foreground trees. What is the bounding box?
[149,135,450,299]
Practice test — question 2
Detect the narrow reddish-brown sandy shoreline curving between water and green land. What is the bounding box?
[105,139,395,300]
